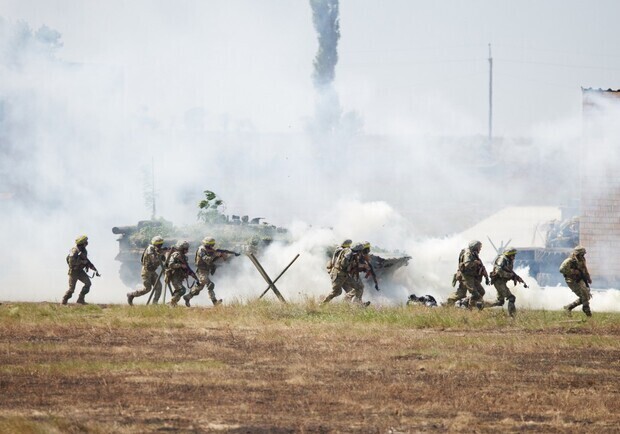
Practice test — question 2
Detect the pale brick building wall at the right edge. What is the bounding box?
[577,89,620,285]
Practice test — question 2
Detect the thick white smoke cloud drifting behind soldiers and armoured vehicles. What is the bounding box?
[0,11,618,310]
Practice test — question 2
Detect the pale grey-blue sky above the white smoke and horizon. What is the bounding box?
[0,0,620,137]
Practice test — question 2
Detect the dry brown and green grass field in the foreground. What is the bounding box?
[0,300,620,433]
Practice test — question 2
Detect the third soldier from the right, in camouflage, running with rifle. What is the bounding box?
[449,240,490,309]
